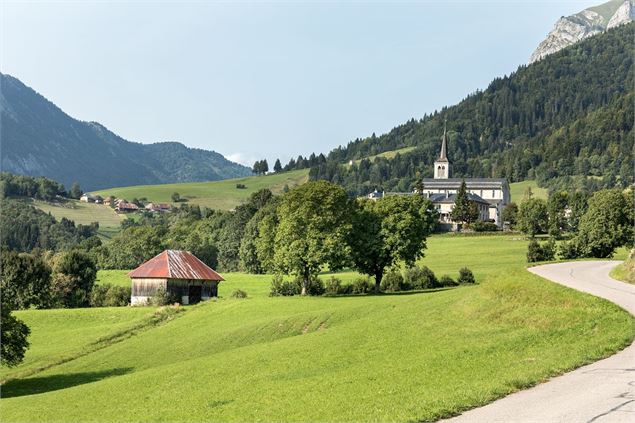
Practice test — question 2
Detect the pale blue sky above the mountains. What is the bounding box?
[0,0,602,167]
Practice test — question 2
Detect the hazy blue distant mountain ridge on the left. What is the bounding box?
[0,74,251,191]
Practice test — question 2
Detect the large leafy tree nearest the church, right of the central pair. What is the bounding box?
[349,195,438,292]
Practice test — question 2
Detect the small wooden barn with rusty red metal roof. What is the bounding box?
[128,250,225,305]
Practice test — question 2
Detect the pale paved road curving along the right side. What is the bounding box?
[447,261,635,423]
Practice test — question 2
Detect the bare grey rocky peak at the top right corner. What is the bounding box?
[529,0,635,64]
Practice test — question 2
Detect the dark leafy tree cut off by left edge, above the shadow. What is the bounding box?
[0,301,31,367]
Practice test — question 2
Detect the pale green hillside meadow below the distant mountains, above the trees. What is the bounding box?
[93,169,309,210]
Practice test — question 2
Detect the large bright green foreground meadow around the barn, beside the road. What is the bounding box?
[0,235,633,421]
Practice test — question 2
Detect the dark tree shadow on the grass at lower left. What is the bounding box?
[1,367,132,398]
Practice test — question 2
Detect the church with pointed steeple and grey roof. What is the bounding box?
[422,127,510,228]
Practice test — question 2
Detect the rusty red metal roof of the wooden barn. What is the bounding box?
[128,250,225,281]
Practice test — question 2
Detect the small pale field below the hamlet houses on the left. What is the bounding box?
[29,200,126,238]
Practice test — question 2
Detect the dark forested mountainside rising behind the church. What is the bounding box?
[285,24,635,195]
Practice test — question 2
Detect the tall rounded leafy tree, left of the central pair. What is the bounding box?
[274,181,351,295]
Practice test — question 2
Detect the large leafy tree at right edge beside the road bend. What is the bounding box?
[574,189,634,258]
